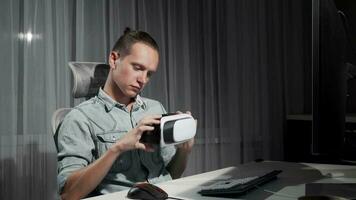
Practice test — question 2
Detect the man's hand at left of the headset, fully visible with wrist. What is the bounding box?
[112,115,162,152]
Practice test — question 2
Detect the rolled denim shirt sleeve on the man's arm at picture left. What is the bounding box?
[57,109,95,193]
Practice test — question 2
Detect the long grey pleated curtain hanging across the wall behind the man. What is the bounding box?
[0,0,311,199]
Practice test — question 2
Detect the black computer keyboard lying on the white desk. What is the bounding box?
[198,170,282,197]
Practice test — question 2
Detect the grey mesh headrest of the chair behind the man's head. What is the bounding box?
[69,62,110,98]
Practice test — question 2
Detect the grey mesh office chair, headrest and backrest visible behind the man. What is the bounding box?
[51,62,110,148]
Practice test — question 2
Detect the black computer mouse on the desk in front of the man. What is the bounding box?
[127,183,168,200]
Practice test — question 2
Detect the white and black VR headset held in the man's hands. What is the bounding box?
[140,114,197,146]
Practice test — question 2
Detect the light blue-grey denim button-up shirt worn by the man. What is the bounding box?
[57,89,176,194]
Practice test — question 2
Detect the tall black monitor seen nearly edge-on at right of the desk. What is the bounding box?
[313,0,346,157]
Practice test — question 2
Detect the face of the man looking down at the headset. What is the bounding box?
[111,42,159,98]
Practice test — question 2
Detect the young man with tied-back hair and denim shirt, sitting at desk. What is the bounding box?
[58,30,194,199]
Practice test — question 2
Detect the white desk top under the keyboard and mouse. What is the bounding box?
[88,161,356,200]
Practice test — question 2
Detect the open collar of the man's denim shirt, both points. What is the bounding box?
[98,88,146,112]
